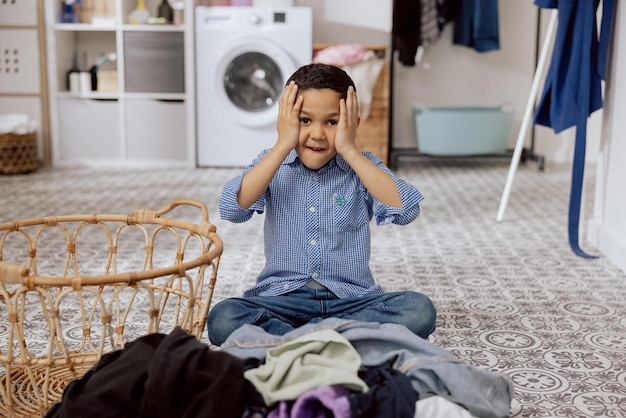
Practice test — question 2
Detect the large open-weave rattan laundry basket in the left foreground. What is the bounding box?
[0,199,223,417]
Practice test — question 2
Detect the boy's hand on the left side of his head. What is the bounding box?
[276,81,304,150]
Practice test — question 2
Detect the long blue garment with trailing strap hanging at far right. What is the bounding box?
[535,0,614,258]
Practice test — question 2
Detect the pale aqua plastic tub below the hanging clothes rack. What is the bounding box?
[413,103,514,156]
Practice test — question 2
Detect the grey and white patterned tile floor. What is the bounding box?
[0,158,626,417]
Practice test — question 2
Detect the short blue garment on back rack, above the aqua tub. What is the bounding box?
[452,0,500,52]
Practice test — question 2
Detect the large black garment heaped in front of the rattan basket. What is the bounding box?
[44,327,246,418]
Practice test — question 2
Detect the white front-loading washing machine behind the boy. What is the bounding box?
[195,6,313,167]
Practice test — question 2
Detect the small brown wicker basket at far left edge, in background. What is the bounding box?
[0,133,39,174]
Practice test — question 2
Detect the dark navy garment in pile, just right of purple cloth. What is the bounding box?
[348,367,419,418]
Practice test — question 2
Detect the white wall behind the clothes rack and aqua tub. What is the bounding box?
[294,0,601,162]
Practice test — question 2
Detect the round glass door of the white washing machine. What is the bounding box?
[208,38,297,128]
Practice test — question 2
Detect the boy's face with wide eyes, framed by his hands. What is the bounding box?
[296,89,341,170]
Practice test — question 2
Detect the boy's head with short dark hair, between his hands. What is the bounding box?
[287,64,358,170]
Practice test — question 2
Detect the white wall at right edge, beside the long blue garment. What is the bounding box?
[588,2,626,272]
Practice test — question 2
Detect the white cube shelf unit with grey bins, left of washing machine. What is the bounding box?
[45,0,196,167]
